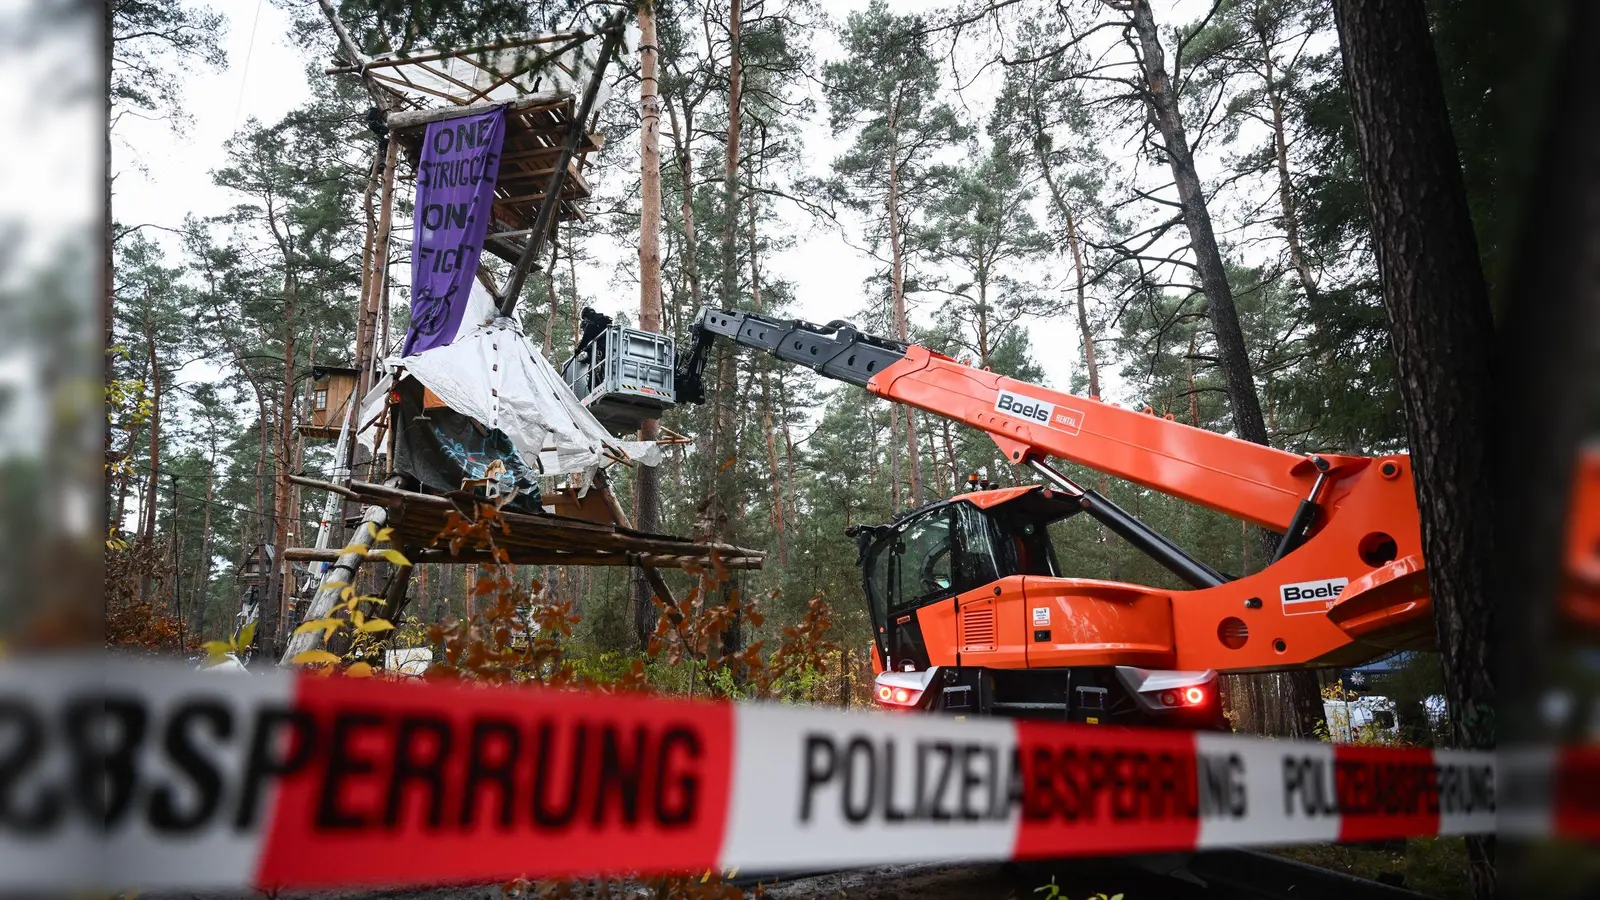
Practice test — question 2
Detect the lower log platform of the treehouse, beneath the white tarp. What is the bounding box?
[285,479,765,569]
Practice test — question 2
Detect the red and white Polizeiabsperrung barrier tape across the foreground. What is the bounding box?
[0,660,1600,889]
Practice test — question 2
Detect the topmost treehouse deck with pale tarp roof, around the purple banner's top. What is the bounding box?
[328,32,608,264]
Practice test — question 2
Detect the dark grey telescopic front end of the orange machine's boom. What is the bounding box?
[677,306,907,404]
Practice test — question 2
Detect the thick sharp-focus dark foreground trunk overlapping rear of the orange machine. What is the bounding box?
[1333,0,1510,897]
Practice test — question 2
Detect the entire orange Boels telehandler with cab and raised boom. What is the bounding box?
[677,307,1587,727]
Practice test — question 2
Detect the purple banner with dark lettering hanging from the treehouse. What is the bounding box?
[400,107,506,356]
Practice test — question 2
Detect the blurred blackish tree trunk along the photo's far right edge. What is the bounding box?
[1490,0,1600,894]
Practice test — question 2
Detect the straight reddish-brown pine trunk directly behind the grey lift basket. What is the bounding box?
[634,0,661,650]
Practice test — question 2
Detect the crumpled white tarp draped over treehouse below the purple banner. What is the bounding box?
[362,301,661,488]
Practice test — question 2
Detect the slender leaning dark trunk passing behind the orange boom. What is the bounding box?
[1130,0,1322,737]
